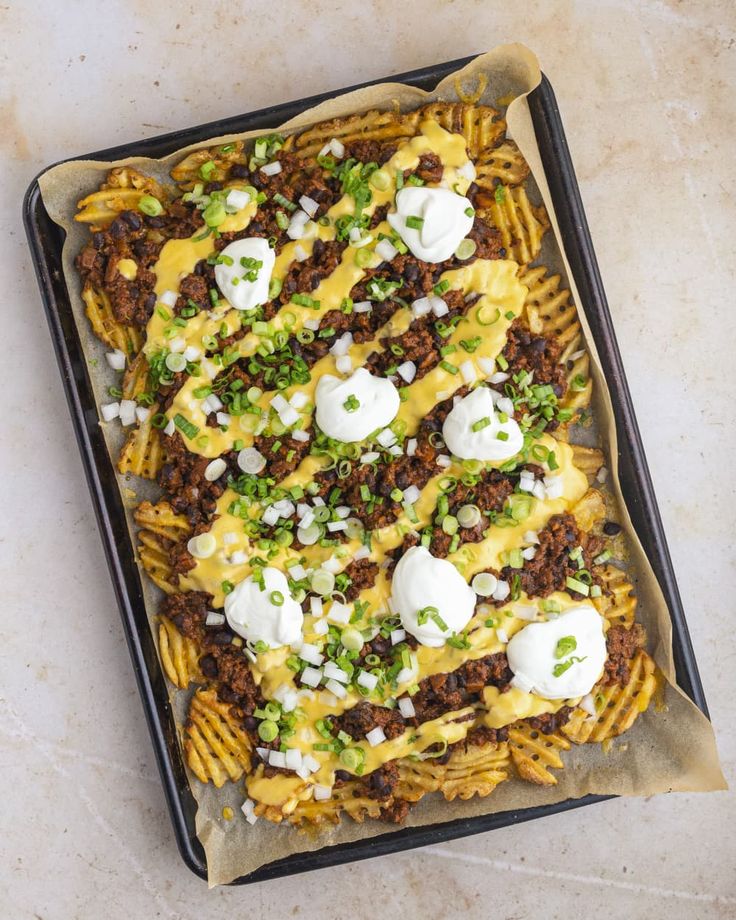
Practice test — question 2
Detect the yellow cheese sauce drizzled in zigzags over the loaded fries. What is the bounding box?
[142,121,587,814]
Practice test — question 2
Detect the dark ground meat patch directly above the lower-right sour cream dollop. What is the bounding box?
[499,514,599,603]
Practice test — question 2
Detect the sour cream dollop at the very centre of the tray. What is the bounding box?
[315,367,401,443]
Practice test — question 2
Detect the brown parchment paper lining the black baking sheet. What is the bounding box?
[40,45,726,886]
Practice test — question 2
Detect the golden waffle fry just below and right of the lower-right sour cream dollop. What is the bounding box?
[562,649,657,744]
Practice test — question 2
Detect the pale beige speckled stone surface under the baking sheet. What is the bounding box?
[0,0,736,920]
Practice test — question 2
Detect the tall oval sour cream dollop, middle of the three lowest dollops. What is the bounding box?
[391,546,476,648]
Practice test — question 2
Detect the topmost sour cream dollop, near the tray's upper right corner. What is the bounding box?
[387,186,473,262]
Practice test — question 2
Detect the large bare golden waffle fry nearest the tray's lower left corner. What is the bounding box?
[184,689,252,789]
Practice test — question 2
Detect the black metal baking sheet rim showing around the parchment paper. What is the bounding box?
[23,56,708,884]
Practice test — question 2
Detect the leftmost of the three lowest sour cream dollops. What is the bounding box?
[225,566,304,648]
